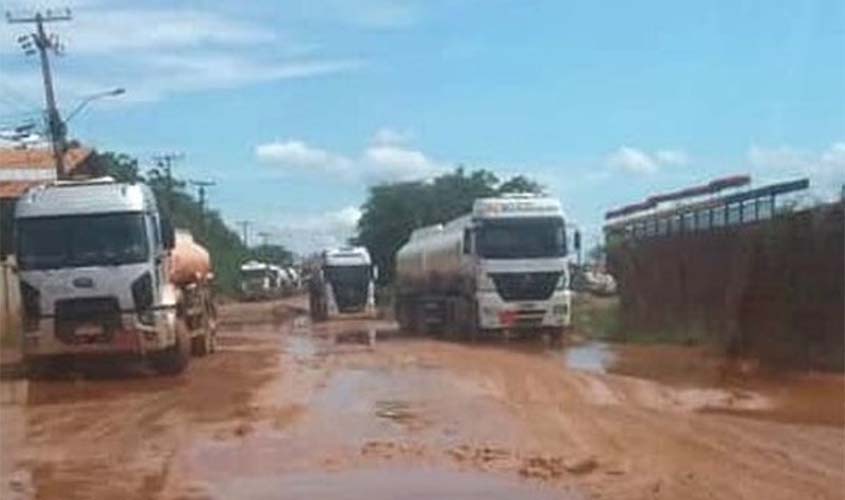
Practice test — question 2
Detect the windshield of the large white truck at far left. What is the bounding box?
[17,213,149,269]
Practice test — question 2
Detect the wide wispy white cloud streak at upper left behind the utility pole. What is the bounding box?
[0,5,363,107]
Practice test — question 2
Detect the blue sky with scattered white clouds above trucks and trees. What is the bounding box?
[0,0,845,251]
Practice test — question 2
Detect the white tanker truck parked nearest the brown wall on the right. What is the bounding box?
[394,195,577,340]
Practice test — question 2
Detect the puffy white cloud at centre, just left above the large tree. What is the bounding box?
[255,129,446,184]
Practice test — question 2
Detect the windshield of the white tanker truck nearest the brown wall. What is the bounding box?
[476,218,566,259]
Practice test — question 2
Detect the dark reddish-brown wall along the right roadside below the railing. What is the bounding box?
[609,203,845,371]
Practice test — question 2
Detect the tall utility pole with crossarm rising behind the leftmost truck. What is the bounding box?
[6,9,71,179]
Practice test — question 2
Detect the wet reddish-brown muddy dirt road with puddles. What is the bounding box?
[0,300,845,500]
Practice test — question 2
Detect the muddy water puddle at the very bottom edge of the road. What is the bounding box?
[199,468,586,500]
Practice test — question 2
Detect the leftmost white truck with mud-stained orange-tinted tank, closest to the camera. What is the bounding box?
[15,178,216,374]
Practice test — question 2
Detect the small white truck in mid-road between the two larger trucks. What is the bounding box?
[309,247,376,321]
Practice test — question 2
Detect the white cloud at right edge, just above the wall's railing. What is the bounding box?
[747,141,845,199]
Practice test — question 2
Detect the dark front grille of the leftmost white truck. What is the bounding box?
[56,297,121,344]
